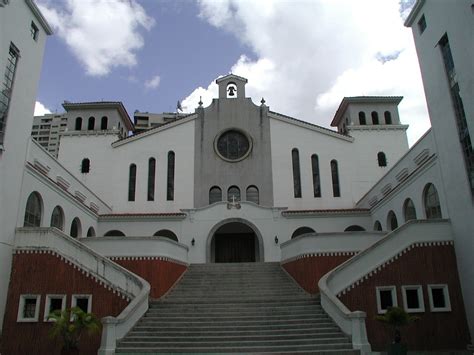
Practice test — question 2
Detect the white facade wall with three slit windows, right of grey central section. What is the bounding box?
[270,114,408,209]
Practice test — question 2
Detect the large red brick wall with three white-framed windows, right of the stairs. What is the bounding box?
[340,245,470,351]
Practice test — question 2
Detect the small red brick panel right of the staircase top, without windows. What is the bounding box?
[282,255,352,294]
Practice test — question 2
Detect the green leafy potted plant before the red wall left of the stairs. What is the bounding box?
[48,307,101,355]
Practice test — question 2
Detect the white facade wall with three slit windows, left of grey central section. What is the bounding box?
[59,121,194,213]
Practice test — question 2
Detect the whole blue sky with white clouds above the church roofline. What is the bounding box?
[32,0,429,143]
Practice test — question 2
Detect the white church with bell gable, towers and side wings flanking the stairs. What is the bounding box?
[0,0,474,354]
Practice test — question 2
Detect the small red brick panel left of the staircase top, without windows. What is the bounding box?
[114,258,187,298]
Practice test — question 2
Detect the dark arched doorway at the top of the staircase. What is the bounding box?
[207,218,263,263]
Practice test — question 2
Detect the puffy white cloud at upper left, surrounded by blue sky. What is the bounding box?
[38,0,154,76]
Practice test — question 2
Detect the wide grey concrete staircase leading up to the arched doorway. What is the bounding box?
[116,263,359,355]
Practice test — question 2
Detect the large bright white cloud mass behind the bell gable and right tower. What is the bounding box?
[190,0,429,143]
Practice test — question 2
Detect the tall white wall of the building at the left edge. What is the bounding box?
[0,0,47,331]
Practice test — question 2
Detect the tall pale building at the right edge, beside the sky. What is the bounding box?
[405,0,474,335]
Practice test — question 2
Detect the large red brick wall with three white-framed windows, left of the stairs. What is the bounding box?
[0,253,128,355]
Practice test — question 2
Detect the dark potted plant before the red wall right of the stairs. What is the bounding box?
[375,307,419,355]
